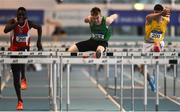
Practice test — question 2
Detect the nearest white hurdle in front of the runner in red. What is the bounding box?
[0,57,60,111]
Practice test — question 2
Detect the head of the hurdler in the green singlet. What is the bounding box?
[91,7,101,24]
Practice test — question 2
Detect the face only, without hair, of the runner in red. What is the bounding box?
[17,10,26,25]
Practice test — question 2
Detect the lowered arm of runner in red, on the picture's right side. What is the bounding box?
[28,21,42,50]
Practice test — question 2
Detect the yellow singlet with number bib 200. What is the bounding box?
[144,17,168,42]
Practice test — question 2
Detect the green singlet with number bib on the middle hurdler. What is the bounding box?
[90,16,111,41]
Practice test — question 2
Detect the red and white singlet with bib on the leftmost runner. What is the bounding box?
[10,20,30,51]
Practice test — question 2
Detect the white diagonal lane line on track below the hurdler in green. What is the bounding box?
[81,69,125,112]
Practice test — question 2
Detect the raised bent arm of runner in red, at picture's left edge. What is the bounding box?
[4,19,18,33]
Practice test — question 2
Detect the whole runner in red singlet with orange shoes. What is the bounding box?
[4,7,42,110]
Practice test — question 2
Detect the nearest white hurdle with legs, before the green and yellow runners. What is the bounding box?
[62,58,180,111]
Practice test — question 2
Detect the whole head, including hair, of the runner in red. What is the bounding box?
[16,7,27,25]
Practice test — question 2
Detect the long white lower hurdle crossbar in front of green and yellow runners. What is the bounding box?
[62,58,180,65]
